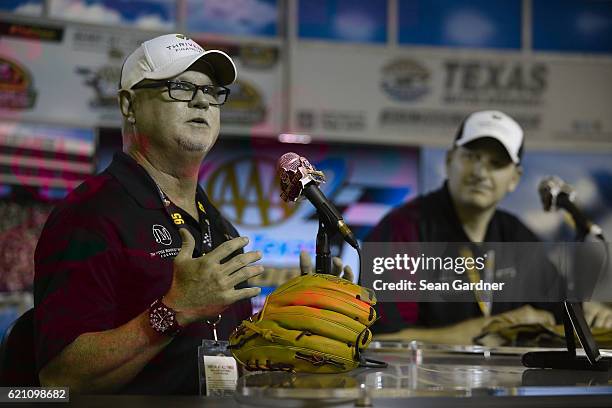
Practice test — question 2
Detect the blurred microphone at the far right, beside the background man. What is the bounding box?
[538,176,603,239]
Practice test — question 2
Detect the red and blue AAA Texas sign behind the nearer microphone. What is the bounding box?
[200,140,418,310]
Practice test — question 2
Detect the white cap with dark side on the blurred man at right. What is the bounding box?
[455,110,523,164]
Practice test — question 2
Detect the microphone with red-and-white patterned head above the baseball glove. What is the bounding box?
[276,152,359,250]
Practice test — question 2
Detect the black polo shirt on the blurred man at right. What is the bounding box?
[365,183,562,333]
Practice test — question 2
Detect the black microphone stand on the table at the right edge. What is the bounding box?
[522,230,612,371]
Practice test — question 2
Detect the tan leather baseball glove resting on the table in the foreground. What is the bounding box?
[229,274,380,373]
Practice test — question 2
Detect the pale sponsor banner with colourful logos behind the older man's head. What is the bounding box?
[0,17,282,135]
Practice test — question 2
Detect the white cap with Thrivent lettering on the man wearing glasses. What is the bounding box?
[119,34,236,89]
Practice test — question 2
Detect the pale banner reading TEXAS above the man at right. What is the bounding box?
[290,43,612,146]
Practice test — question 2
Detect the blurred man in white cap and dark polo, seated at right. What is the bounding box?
[366,111,612,344]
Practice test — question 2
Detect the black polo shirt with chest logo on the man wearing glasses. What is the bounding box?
[34,153,252,394]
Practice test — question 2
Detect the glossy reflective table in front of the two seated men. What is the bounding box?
[15,342,612,408]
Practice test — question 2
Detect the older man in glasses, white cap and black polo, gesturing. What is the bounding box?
[34,34,262,394]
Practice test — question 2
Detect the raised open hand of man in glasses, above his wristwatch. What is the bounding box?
[164,228,263,325]
